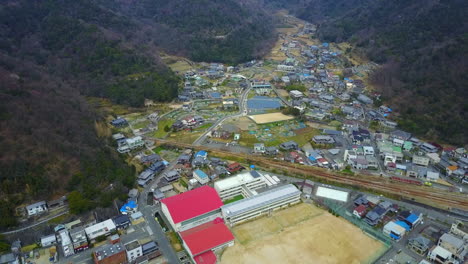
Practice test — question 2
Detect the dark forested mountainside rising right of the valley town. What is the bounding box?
[271,0,468,144]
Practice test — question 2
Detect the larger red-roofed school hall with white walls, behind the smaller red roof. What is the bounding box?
[161,186,223,231]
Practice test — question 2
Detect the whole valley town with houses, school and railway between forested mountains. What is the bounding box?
[0,10,468,264]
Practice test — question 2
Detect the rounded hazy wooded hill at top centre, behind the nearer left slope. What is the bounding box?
[105,0,275,63]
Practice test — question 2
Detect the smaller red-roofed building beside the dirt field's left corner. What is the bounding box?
[179,219,234,263]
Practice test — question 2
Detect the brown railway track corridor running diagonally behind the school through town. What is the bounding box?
[156,139,468,210]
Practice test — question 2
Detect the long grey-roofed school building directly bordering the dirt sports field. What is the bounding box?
[221,184,301,226]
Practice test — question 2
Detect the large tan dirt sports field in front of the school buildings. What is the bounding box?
[220,203,386,264]
